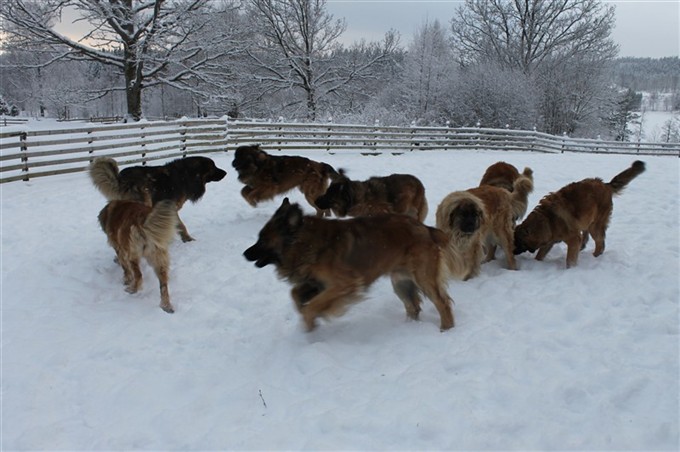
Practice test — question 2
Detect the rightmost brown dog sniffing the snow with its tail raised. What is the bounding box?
[514,160,645,268]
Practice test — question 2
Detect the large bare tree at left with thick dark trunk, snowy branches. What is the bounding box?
[0,0,244,119]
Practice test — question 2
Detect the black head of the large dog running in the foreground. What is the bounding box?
[243,198,303,268]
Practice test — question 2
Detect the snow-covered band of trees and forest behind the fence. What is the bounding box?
[0,0,680,140]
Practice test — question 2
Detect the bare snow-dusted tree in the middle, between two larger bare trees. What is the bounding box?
[247,0,398,121]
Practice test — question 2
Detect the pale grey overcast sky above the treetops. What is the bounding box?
[327,0,680,58]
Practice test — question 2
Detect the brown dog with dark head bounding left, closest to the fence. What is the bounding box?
[232,145,338,216]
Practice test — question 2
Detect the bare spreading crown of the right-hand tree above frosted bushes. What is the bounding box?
[451,0,617,73]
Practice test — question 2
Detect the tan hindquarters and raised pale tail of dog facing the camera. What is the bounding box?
[468,168,534,270]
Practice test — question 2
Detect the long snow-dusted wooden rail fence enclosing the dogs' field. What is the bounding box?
[0,118,680,183]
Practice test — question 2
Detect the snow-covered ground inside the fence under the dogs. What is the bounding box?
[0,147,680,450]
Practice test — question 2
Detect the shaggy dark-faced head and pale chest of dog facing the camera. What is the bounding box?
[435,191,488,280]
